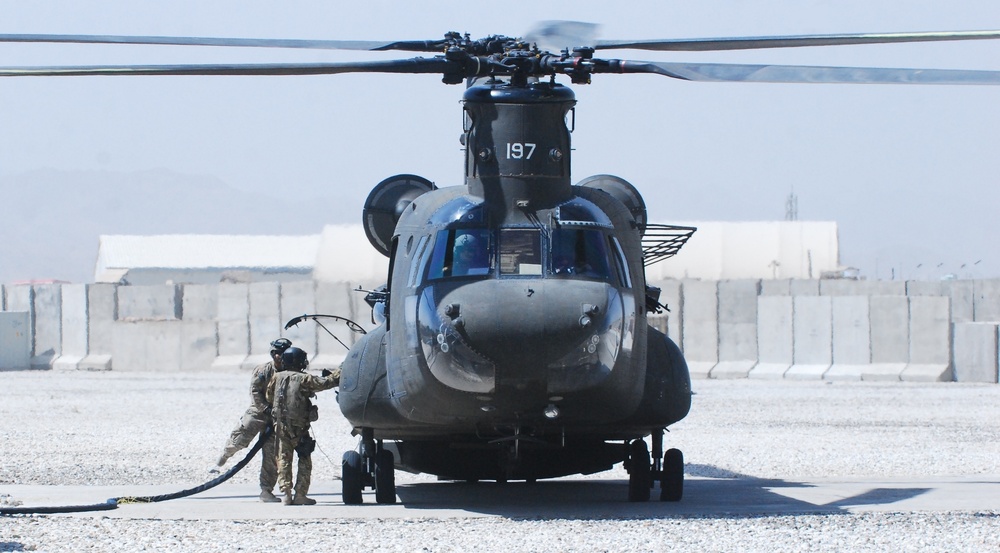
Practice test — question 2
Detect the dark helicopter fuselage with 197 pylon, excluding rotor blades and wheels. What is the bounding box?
[340,77,690,477]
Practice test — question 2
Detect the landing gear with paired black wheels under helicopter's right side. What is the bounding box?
[625,428,684,501]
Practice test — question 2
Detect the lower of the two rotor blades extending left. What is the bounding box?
[0,57,452,77]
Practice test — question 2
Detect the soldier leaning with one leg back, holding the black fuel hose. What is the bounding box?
[218,338,292,503]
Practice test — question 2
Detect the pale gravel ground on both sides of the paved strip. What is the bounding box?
[0,371,1000,552]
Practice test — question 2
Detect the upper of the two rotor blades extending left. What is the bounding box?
[0,34,445,52]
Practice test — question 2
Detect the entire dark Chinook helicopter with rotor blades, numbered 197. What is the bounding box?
[0,23,1000,503]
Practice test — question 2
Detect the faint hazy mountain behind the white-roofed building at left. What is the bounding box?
[0,170,361,283]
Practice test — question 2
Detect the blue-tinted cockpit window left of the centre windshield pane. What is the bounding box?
[427,228,491,280]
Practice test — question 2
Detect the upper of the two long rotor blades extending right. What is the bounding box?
[594,31,1000,52]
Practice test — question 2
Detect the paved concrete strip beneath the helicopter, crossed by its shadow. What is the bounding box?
[0,476,1000,520]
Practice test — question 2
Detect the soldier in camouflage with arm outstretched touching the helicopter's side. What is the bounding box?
[267,347,340,505]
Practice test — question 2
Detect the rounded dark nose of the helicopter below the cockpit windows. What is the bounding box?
[418,280,623,394]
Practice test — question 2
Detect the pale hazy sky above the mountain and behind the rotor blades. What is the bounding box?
[0,0,1000,278]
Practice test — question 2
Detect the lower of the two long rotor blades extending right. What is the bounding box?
[595,60,1000,85]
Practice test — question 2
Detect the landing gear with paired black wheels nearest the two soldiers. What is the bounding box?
[340,428,396,505]
